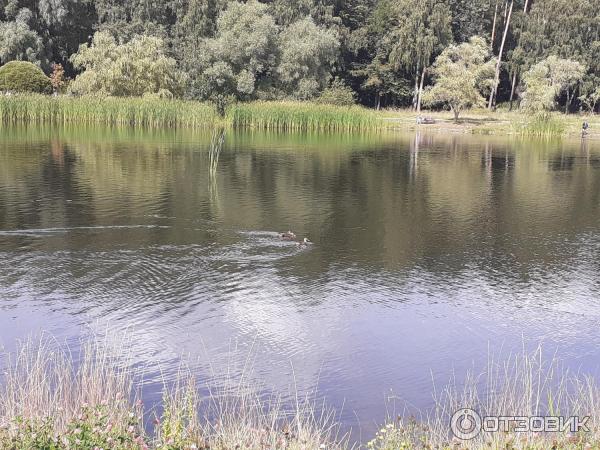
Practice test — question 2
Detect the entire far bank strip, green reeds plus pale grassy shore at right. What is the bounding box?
[0,94,600,141]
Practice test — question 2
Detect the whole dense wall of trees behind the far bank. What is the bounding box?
[0,0,600,112]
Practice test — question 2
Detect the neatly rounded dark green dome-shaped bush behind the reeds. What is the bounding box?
[0,61,52,94]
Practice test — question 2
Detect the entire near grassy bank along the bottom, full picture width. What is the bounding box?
[0,341,600,450]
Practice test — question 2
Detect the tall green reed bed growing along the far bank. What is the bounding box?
[0,95,383,132]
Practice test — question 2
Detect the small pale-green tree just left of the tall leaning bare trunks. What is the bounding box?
[424,37,494,120]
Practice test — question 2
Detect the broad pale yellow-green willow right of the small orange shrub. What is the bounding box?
[71,32,181,97]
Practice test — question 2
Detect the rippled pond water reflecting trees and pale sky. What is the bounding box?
[0,127,600,437]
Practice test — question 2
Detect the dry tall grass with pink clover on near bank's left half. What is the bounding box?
[0,340,346,450]
